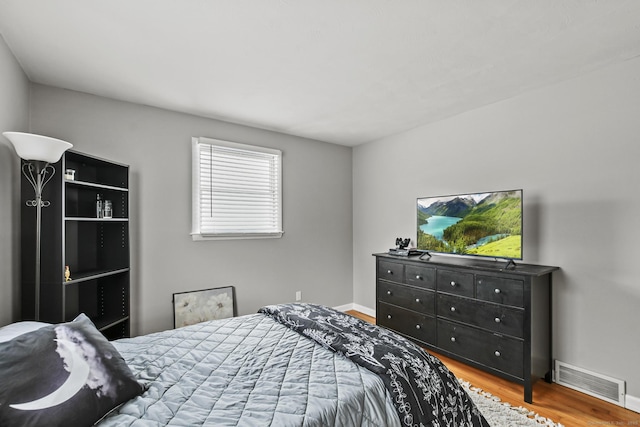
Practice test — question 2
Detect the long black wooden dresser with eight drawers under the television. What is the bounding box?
[374,254,558,403]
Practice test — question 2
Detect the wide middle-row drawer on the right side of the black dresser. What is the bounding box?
[437,294,524,338]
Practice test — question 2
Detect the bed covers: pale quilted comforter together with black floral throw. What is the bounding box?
[100,305,488,427]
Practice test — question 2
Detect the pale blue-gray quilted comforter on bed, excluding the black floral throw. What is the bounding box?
[99,314,400,427]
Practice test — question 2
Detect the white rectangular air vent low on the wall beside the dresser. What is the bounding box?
[555,360,625,407]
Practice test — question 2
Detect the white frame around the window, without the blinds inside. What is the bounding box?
[191,136,284,241]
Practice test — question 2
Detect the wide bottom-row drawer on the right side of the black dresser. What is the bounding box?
[437,319,524,379]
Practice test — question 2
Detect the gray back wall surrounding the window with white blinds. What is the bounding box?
[26,85,353,333]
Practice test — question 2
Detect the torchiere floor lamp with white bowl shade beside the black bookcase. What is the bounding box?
[2,132,73,320]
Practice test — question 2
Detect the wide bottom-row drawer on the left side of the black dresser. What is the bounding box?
[376,302,436,345]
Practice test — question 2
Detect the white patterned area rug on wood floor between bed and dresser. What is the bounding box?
[459,380,564,427]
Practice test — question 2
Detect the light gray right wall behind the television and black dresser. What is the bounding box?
[353,59,640,397]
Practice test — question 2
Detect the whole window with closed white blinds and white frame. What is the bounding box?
[191,137,283,240]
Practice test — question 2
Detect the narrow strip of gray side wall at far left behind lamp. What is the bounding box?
[0,36,29,326]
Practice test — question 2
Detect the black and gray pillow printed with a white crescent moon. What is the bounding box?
[0,314,142,426]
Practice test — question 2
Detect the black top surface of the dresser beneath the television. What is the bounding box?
[373,253,560,276]
